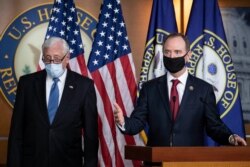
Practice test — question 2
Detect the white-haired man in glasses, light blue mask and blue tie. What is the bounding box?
[7,37,98,167]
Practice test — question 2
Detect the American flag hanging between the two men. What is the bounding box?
[88,0,142,167]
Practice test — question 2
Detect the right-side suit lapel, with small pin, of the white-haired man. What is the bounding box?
[52,70,76,125]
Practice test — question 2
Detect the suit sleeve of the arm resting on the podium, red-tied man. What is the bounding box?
[205,86,232,145]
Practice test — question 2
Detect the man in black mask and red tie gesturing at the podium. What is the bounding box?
[114,33,246,164]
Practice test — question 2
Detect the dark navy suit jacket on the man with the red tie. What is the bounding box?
[124,75,232,146]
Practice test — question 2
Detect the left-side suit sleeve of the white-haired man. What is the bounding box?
[7,77,25,167]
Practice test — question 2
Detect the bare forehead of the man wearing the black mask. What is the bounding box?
[164,37,186,50]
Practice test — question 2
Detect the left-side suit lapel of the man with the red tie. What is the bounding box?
[158,75,171,119]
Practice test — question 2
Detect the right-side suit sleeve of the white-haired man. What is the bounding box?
[83,82,99,167]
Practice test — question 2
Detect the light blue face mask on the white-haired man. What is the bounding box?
[45,63,65,78]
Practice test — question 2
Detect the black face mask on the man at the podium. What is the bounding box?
[163,52,188,73]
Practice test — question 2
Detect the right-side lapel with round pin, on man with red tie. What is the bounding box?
[176,74,195,119]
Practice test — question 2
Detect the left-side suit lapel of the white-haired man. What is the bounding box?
[35,70,49,125]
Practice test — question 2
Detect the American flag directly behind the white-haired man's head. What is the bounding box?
[39,0,87,76]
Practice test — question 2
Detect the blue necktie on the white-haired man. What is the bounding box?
[48,78,59,124]
